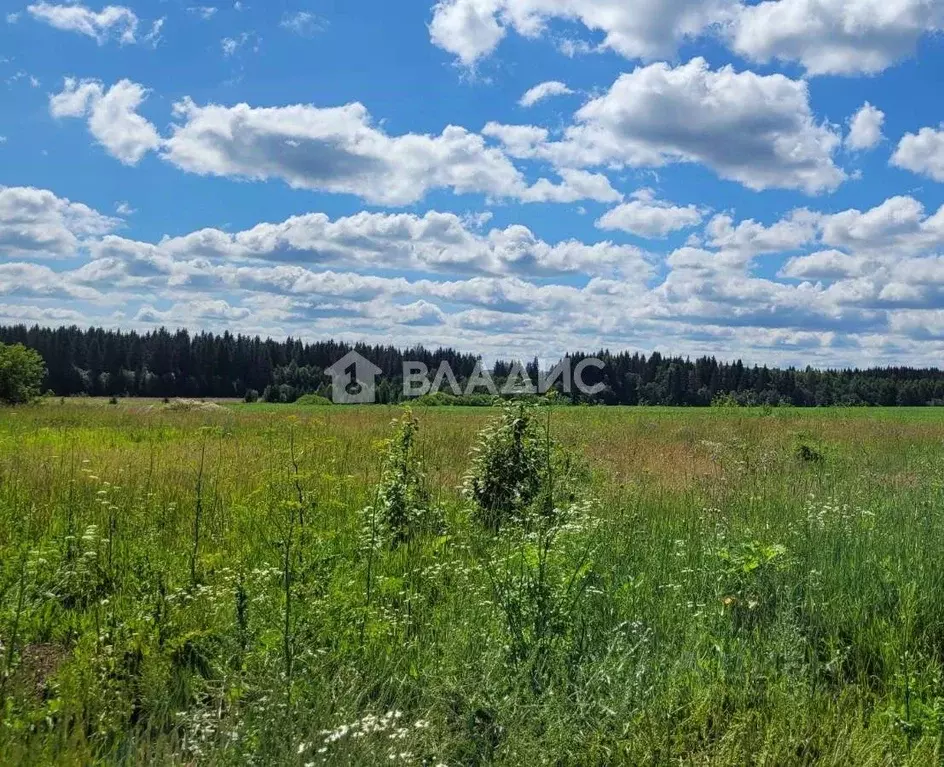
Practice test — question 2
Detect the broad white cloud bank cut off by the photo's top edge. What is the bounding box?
[429,0,944,75]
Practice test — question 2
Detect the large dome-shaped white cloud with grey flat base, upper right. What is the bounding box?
[543,58,845,194]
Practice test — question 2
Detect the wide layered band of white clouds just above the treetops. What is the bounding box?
[12,188,944,364]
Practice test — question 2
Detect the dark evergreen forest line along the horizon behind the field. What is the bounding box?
[0,325,944,407]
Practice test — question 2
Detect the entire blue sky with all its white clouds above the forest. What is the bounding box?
[0,0,944,366]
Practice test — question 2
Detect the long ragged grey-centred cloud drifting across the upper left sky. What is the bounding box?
[50,79,621,205]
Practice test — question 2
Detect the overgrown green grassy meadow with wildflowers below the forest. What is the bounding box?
[0,400,944,765]
